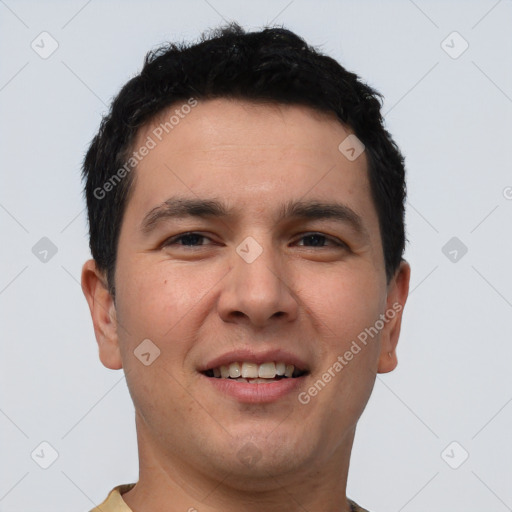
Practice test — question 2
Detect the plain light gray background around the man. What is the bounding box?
[0,0,512,512]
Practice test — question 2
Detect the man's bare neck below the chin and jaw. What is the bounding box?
[123,418,355,512]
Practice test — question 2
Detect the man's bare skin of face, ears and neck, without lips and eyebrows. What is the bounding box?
[82,99,410,512]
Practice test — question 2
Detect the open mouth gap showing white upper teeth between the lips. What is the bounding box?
[202,361,308,384]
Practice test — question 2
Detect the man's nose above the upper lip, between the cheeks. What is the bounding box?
[217,240,298,328]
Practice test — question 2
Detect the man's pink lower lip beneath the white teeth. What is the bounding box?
[203,375,306,404]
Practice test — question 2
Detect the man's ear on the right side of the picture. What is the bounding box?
[377,260,411,373]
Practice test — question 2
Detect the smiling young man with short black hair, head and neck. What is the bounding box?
[82,24,410,512]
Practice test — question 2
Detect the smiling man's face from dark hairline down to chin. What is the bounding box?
[85,99,408,485]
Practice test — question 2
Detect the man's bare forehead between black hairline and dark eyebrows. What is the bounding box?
[128,99,376,234]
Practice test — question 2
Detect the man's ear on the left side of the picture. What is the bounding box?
[82,260,123,370]
